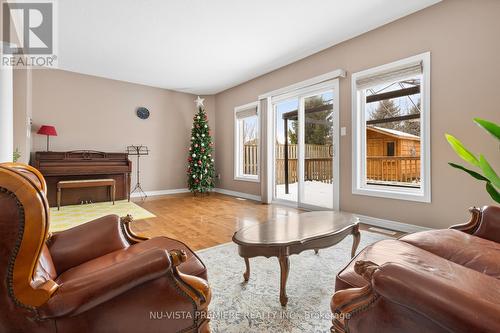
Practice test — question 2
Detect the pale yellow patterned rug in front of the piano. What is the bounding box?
[50,200,155,232]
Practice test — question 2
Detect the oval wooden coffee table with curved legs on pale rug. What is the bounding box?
[233,211,360,306]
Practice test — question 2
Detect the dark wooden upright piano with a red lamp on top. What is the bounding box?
[34,150,132,206]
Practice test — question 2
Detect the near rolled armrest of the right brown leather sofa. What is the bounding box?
[369,263,500,332]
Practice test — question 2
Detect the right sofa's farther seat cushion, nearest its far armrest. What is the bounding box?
[399,229,500,279]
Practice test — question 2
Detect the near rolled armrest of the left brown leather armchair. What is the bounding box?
[38,249,172,319]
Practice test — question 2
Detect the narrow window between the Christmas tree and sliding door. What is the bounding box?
[234,102,260,181]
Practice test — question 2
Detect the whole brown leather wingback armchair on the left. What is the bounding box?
[0,163,211,333]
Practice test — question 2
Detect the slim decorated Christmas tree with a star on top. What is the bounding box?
[187,96,215,193]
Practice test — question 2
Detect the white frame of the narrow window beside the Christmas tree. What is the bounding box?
[234,101,261,183]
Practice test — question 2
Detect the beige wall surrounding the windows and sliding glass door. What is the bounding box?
[215,0,500,227]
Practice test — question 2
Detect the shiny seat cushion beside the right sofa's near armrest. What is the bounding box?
[335,239,482,291]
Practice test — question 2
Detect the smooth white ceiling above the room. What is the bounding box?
[58,0,439,94]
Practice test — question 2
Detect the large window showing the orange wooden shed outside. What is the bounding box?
[352,53,430,202]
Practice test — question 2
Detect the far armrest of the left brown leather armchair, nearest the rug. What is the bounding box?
[47,215,130,274]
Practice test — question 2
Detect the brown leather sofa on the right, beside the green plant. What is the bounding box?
[331,206,500,333]
